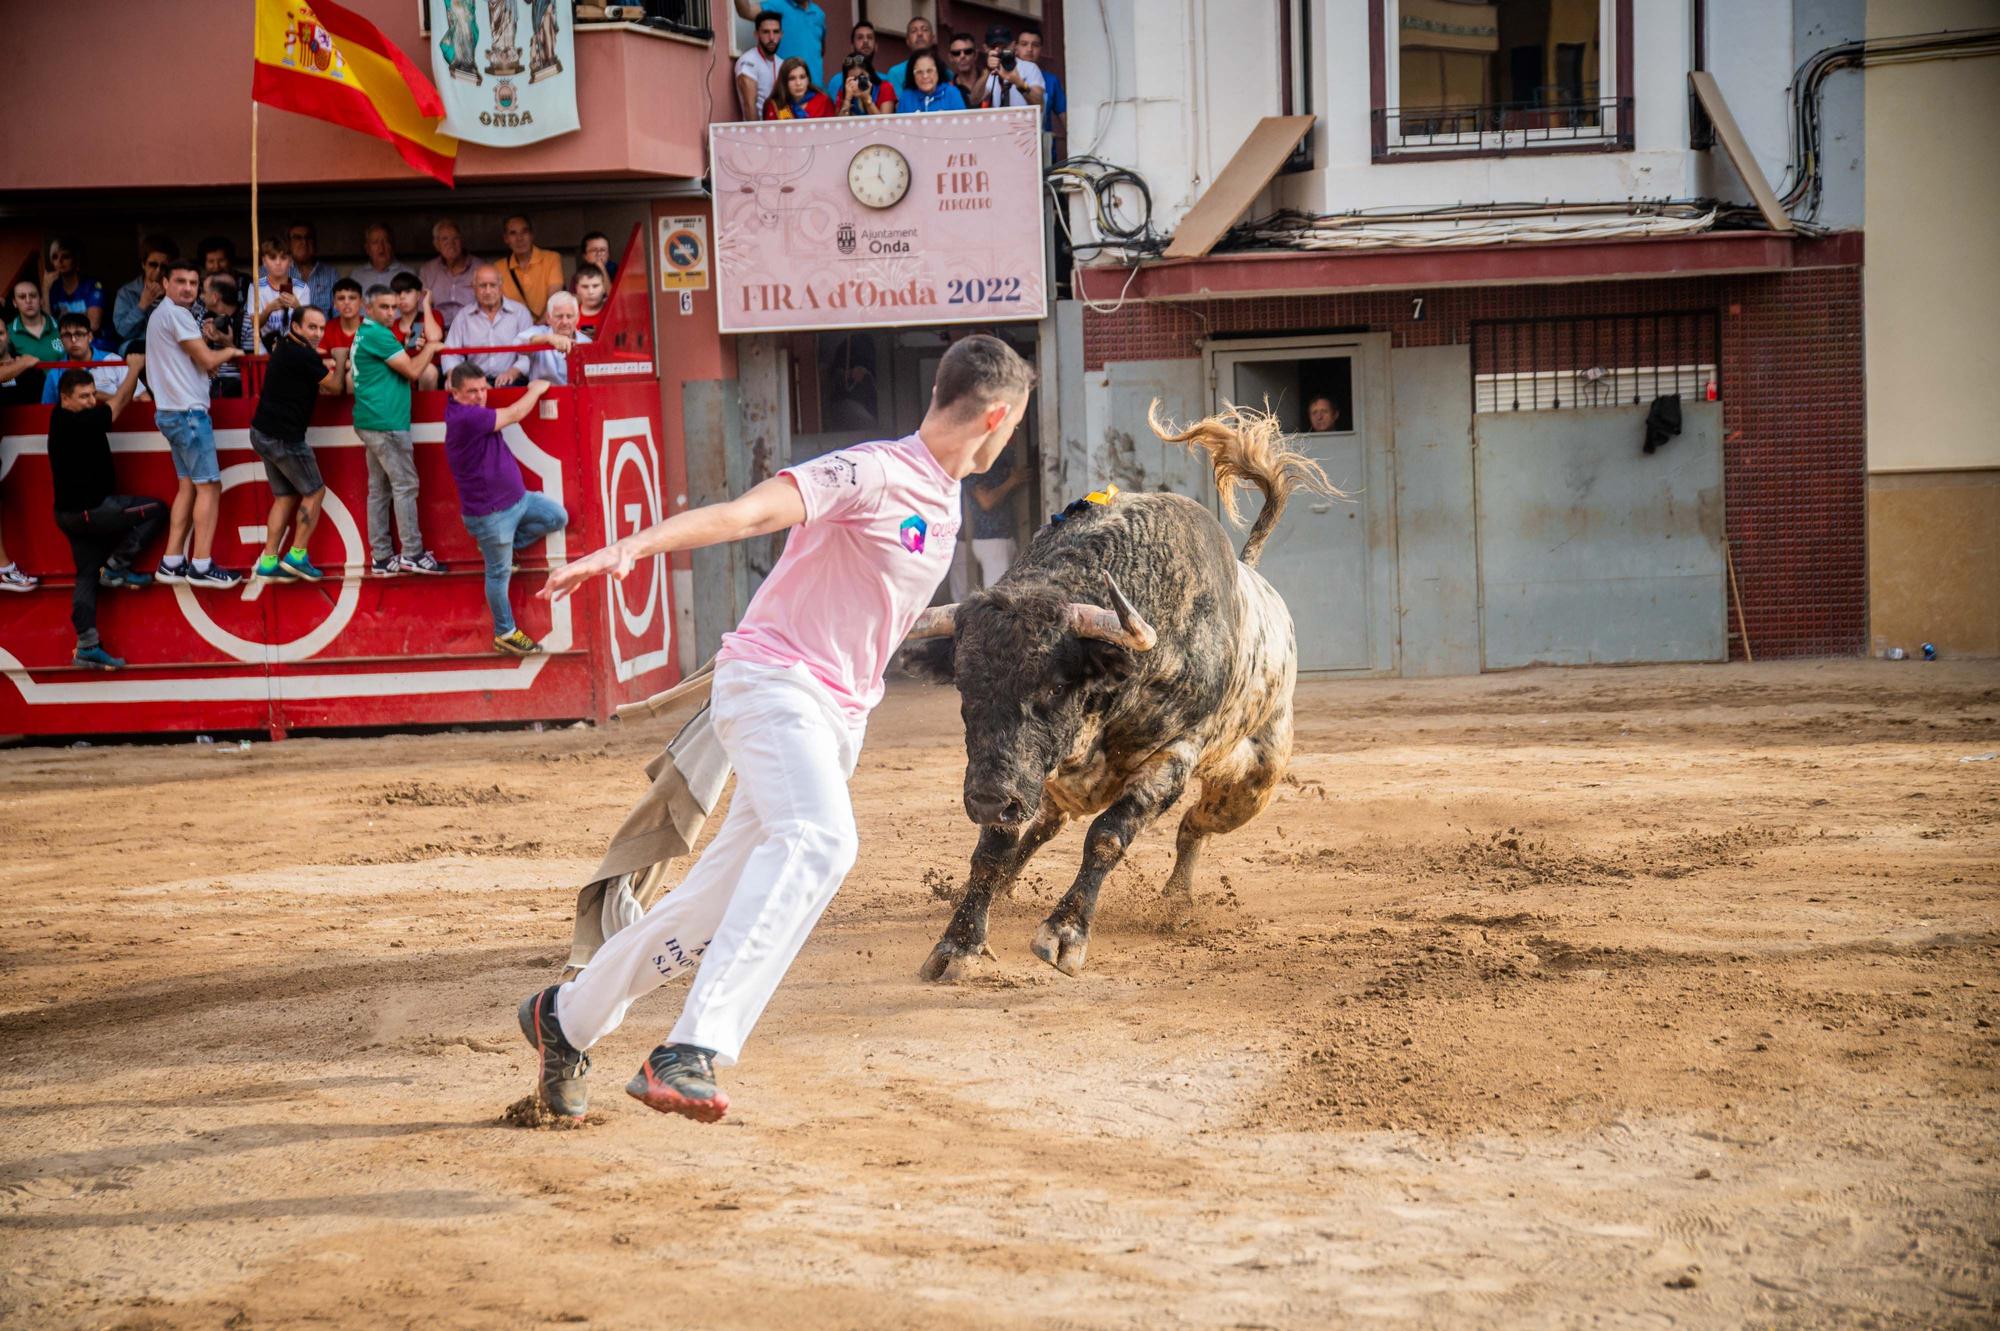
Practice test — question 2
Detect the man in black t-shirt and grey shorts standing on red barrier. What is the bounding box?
[250,306,334,582]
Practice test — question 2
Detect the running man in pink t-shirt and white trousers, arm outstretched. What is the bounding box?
[520,334,1034,1123]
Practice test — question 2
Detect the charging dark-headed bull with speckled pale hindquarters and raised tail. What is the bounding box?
[902,404,1338,981]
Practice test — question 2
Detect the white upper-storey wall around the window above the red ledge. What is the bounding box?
[1064,0,1824,242]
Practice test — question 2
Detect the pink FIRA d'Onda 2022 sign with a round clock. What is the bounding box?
[708,106,1048,334]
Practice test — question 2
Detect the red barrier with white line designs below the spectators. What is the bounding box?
[0,367,680,737]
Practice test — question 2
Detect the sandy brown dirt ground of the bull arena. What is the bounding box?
[0,662,2000,1329]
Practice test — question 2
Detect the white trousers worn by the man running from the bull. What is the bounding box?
[556,662,862,1067]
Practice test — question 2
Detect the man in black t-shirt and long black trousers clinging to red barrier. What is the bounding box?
[48,354,168,669]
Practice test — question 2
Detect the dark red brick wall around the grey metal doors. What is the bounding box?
[1084,268,1868,658]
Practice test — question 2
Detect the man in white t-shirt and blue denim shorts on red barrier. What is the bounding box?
[146,260,242,588]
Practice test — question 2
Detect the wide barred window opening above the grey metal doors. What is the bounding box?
[1472,310,1722,412]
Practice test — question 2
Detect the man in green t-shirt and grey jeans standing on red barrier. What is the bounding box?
[352,286,446,578]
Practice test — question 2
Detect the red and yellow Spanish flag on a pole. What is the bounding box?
[250,0,458,184]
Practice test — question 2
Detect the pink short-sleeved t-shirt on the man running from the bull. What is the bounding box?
[716,434,960,723]
